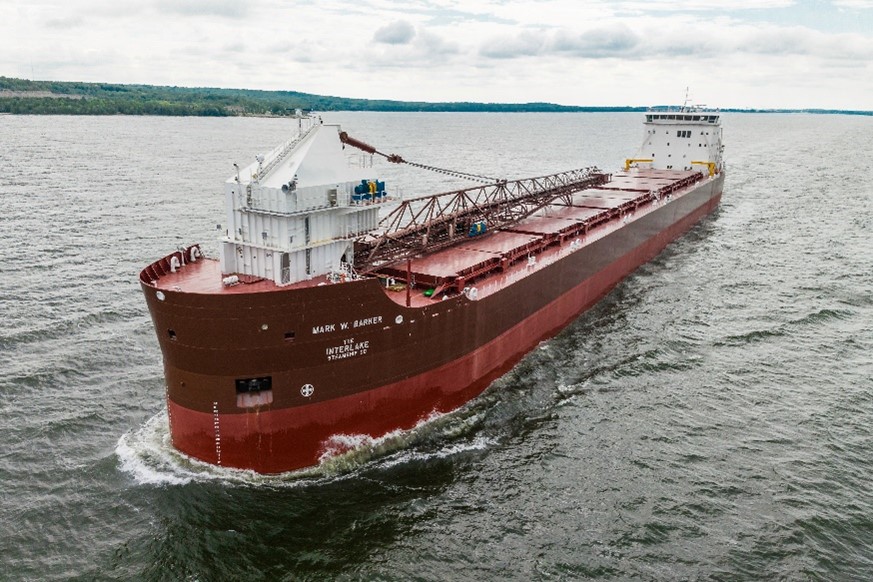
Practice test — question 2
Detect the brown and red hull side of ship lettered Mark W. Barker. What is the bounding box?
[143,175,724,473]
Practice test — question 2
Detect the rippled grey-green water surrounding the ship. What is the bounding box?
[0,113,873,580]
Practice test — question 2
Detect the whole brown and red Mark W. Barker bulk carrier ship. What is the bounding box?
[140,107,725,473]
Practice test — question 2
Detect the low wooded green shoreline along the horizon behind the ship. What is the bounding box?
[0,76,873,117]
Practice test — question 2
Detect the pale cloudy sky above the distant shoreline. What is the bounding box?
[0,0,873,110]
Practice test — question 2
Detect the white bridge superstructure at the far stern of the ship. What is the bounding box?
[626,107,724,175]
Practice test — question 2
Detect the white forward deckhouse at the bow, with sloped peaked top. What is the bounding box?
[221,117,385,285]
